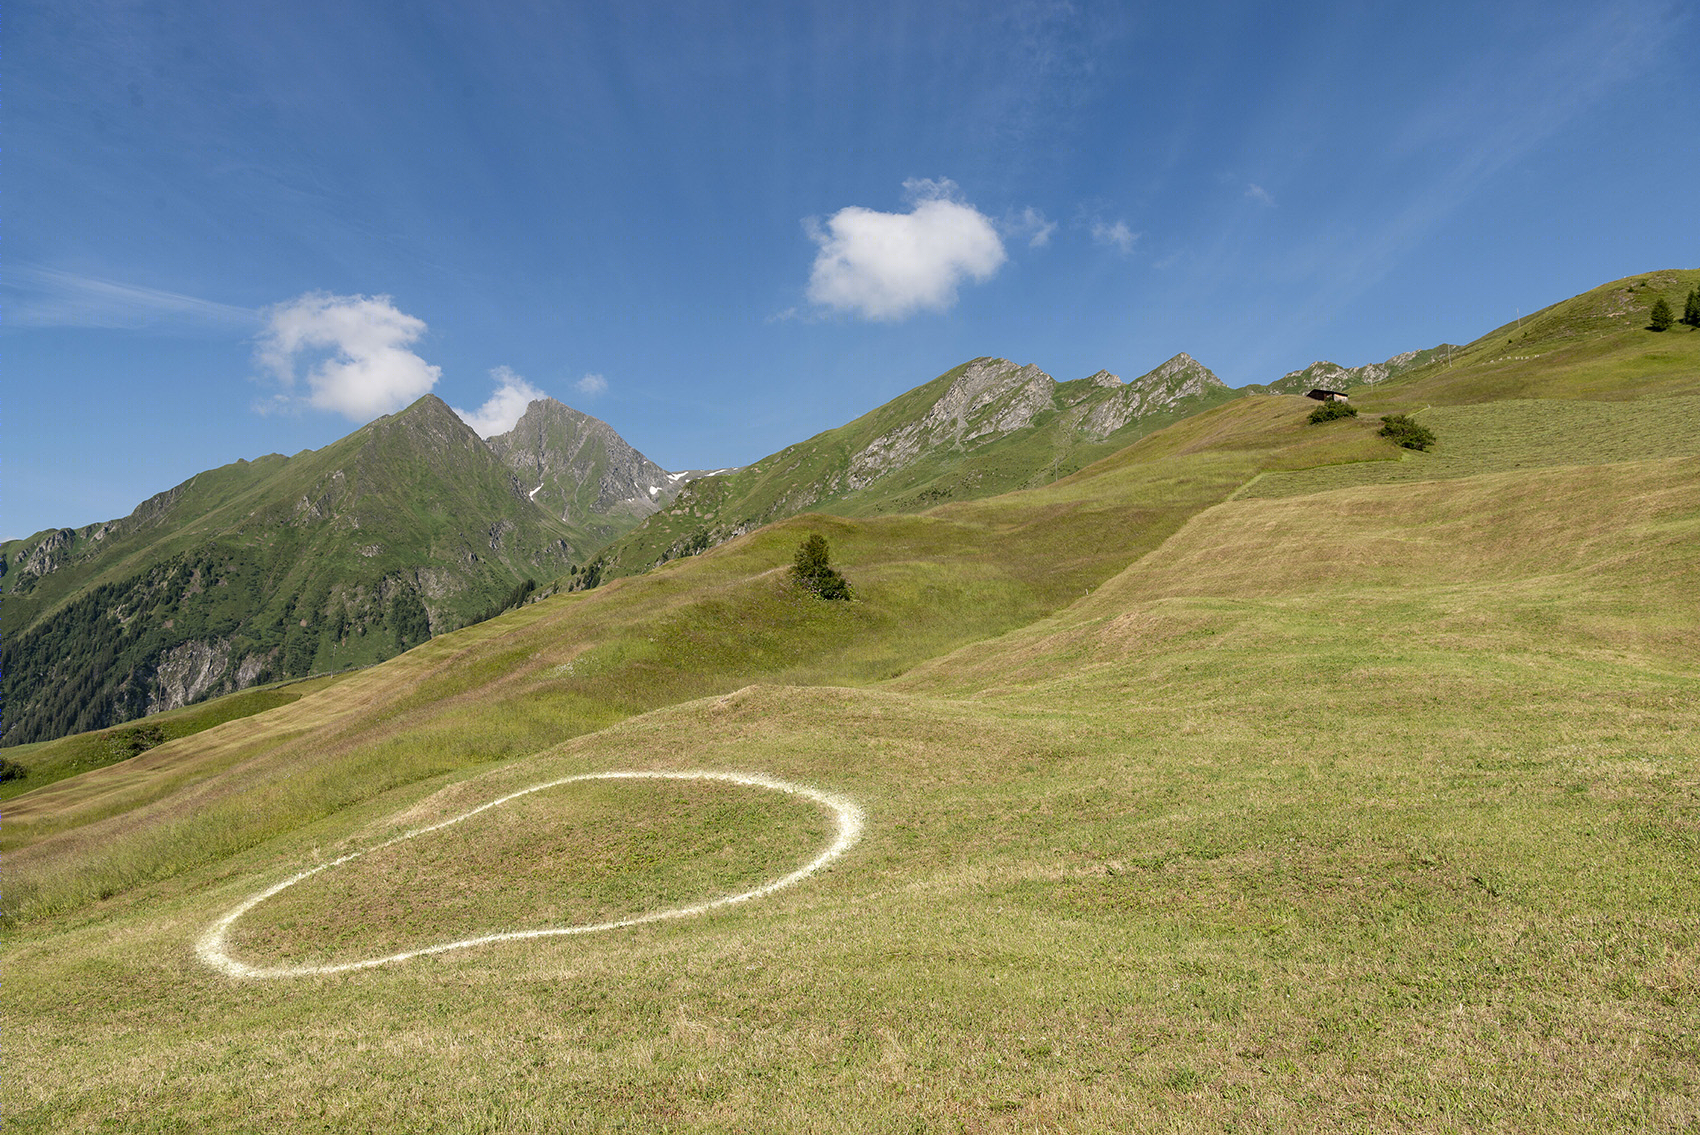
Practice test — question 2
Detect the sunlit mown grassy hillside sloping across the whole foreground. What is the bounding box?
[0,270,1700,1132]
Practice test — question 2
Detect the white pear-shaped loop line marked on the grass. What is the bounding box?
[196,771,862,977]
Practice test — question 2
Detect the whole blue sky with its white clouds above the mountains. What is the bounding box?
[0,0,1700,537]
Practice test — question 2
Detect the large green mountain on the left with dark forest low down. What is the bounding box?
[0,396,570,744]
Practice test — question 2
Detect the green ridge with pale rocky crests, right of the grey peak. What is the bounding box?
[602,355,1236,576]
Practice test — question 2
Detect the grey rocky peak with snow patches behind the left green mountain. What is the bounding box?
[490,398,680,525]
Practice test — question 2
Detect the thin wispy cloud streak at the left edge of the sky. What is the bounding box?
[5,265,262,333]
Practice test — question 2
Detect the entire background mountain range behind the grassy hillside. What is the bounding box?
[0,282,1666,744]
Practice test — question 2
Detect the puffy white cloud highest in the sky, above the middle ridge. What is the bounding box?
[804,178,1006,319]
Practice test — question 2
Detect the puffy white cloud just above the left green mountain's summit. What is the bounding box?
[255,292,442,421]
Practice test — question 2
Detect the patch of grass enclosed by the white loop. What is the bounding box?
[230,765,831,965]
